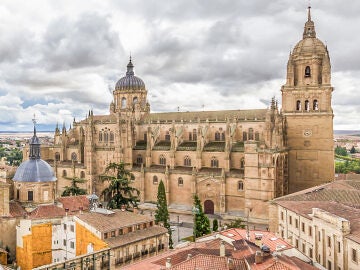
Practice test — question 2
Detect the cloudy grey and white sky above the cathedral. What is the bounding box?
[0,0,360,131]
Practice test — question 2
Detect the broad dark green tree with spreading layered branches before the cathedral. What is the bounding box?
[101,162,140,209]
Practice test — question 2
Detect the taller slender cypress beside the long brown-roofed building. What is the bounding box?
[155,180,173,248]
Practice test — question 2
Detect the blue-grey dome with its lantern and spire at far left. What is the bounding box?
[13,122,56,182]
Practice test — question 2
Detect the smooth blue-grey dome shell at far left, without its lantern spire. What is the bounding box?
[13,159,56,182]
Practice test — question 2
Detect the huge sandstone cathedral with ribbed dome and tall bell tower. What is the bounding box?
[24,8,334,223]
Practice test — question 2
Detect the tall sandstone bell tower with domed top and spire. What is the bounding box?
[281,7,334,192]
